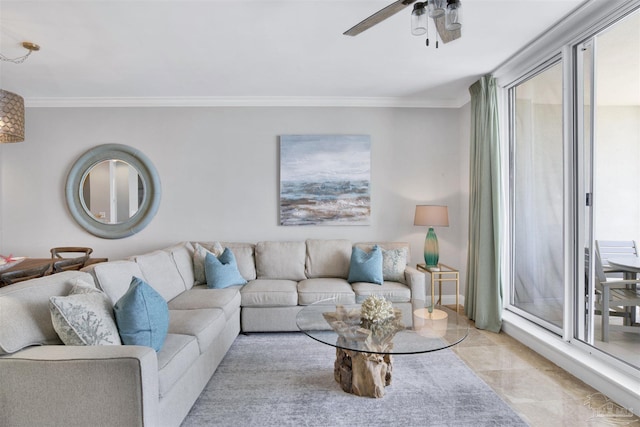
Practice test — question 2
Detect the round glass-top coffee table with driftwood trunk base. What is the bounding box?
[296,300,469,397]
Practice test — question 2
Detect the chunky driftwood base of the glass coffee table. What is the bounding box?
[333,348,392,398]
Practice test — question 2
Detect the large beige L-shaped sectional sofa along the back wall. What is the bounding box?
[0,240,426,426]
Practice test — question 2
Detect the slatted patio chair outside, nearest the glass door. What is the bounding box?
[594,248,640,342]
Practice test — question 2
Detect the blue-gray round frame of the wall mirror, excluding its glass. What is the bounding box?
[65,144,162,239]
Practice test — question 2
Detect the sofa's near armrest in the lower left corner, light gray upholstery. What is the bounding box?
[0,345,158,426]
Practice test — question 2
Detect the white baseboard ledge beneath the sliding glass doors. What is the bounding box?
[502,310,640,415]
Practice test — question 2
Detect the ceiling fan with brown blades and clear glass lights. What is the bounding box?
[343,0,462,47]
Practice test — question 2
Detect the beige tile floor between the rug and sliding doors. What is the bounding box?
[453,322,640,427]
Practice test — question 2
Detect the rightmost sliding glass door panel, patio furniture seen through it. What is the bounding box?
[575,11,640,367]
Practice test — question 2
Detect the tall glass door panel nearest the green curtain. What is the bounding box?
[509,58,565,333]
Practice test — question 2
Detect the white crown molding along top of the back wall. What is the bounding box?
[25,96,468,108]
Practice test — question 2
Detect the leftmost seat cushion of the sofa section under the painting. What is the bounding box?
[240,279,298,307]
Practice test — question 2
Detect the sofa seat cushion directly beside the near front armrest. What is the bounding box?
[158,334,200,398]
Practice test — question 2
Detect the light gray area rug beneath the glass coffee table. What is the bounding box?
[183,333,527,427]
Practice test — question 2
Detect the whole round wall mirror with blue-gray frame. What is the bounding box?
[66,144,161,239]
